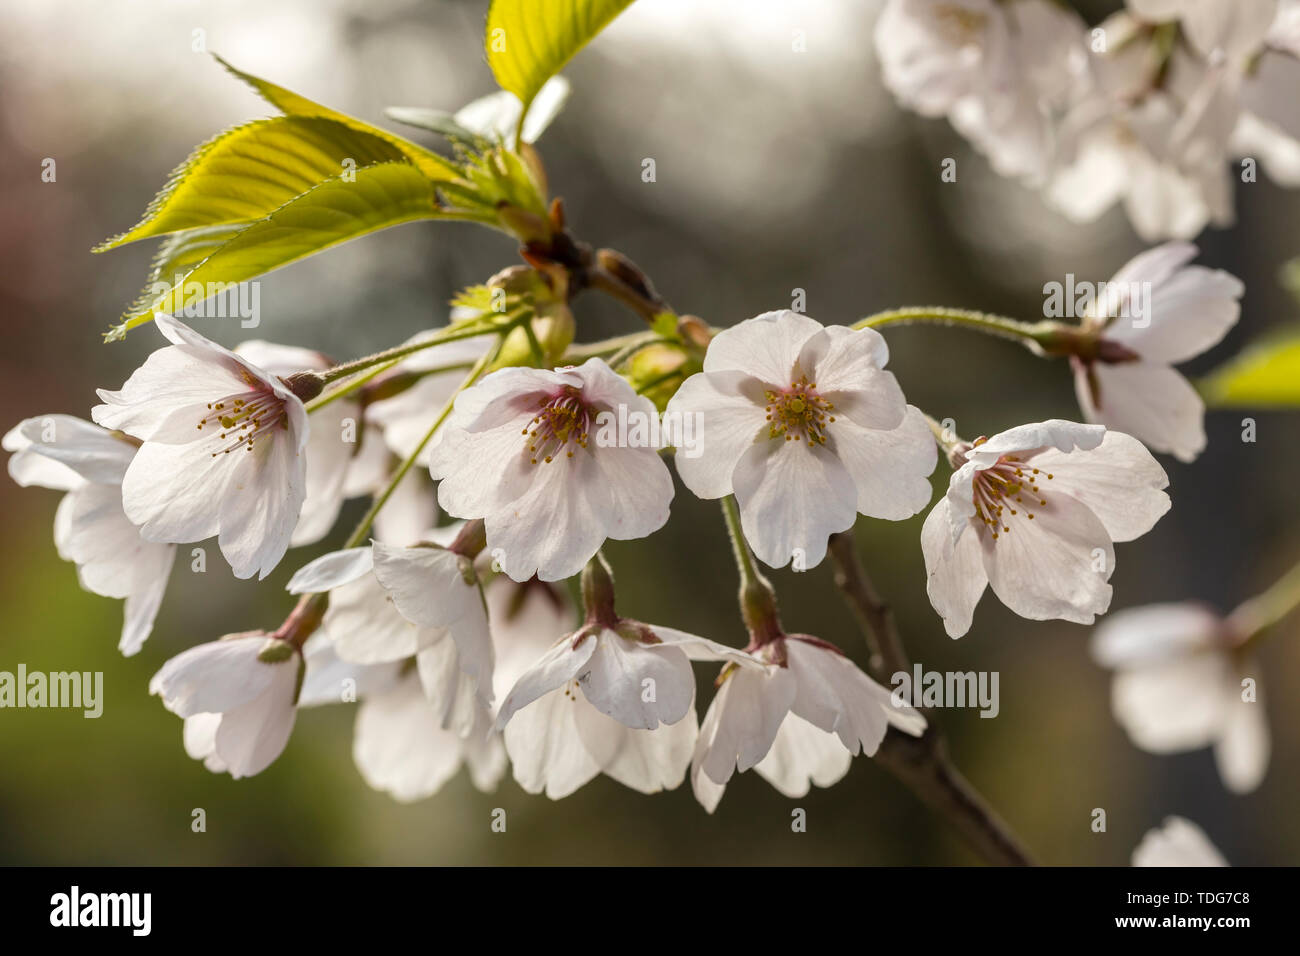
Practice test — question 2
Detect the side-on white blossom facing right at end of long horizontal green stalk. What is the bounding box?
[1071,242,1244,462]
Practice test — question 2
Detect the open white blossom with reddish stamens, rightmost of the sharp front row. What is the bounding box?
[920,419,1169,637]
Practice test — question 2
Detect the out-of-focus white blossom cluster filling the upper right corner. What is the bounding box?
[875,0,1300,241]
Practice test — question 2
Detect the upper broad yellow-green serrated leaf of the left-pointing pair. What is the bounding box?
[95,116,406,252]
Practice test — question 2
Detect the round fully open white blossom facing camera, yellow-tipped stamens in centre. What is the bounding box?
[667,311,937,567]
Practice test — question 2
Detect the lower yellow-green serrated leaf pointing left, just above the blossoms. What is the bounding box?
[107,161,477,339]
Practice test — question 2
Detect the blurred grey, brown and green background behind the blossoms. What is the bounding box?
[0,0,1300,865]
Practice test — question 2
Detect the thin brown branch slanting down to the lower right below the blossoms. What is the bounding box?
[829,531,1034,866]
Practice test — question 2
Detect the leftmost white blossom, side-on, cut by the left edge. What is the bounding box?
[3,415,176,657]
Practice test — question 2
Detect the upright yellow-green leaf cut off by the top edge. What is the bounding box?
[484,0,632,125]
